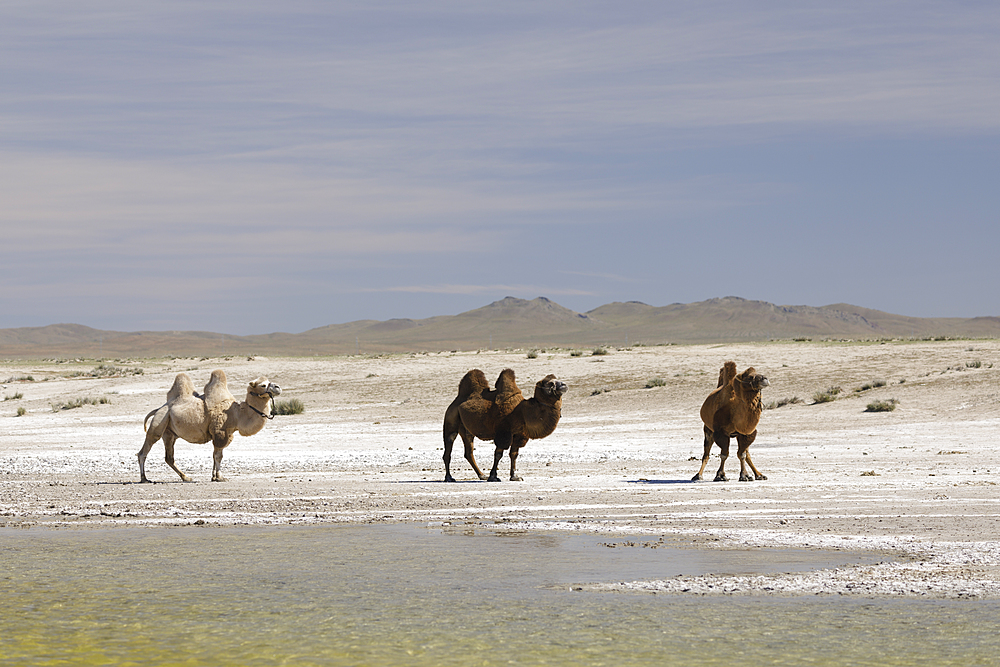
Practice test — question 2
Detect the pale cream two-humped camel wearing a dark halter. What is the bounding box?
[138,370,281,482]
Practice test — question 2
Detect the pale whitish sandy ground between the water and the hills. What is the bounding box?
[0,341,1000,598]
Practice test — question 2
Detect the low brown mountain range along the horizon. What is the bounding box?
[0,296,1000,358]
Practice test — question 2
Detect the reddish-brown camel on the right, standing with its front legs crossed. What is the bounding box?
[691,361,770,482]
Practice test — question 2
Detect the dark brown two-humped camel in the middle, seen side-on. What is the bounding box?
[444,368,568,482]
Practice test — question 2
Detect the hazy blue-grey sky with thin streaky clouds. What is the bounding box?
[0,0,1000,334]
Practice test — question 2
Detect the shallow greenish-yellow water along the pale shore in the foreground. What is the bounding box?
[0,526,1000,666]
